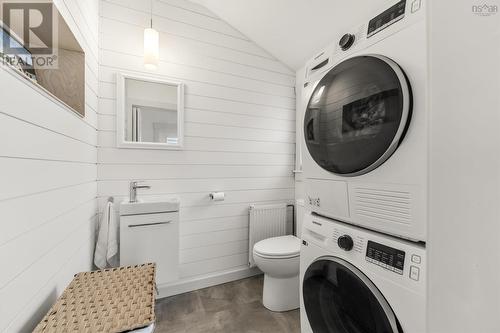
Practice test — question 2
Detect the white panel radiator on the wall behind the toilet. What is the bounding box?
[248,203,287,267]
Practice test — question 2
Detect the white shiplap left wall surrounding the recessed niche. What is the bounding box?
[0,0,99,332]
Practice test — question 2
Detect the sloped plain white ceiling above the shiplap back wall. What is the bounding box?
[192,0,390,69]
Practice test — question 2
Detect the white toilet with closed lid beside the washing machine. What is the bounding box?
[253,236,300,312]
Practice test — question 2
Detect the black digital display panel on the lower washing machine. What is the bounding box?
[366,241,405,275]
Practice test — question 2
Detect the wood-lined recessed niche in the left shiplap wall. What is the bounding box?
[0,0,85,117]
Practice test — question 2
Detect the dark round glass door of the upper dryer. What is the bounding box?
[304,55,412,176]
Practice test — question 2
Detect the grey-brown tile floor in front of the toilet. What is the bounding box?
[155,276,300,333]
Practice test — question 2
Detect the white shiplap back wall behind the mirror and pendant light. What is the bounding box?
[98,0,295,290]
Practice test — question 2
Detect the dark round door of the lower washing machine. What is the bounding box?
[302,257,403,333]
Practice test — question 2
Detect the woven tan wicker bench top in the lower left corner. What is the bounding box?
[34,264,156,333]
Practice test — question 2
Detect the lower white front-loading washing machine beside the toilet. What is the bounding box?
[300,215,426,333]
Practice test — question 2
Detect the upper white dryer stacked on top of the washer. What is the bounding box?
[302,0,428,241]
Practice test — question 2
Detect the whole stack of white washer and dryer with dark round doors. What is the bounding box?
[300,0,428,333]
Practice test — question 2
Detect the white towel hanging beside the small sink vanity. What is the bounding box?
[94,202,118,269]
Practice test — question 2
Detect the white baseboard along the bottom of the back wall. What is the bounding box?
[158,267,262,298]
